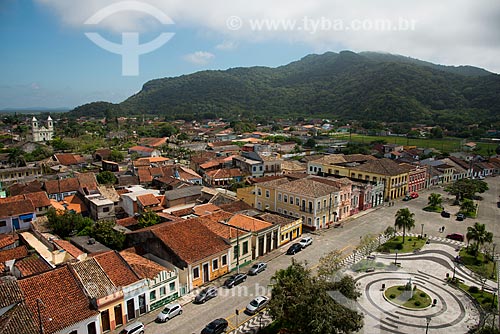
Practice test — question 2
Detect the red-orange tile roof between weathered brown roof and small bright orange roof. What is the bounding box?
[94,251,139,287]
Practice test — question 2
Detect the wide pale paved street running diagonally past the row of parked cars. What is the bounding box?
[123,178,500,334]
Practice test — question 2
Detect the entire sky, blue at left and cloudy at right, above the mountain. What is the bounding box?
[0,0,500,109]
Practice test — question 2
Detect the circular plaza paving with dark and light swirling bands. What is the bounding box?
[353,243,495,334]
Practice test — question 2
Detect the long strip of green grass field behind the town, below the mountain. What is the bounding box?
[332,133,497,154]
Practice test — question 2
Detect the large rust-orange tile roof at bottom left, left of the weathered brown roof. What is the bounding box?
[19,267,98,333]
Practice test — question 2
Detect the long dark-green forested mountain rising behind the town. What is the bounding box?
[73,51,500,124]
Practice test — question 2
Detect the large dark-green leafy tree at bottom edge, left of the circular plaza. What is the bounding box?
[269,261,363,334]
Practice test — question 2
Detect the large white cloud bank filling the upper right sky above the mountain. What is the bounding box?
[36,0,500,72]
